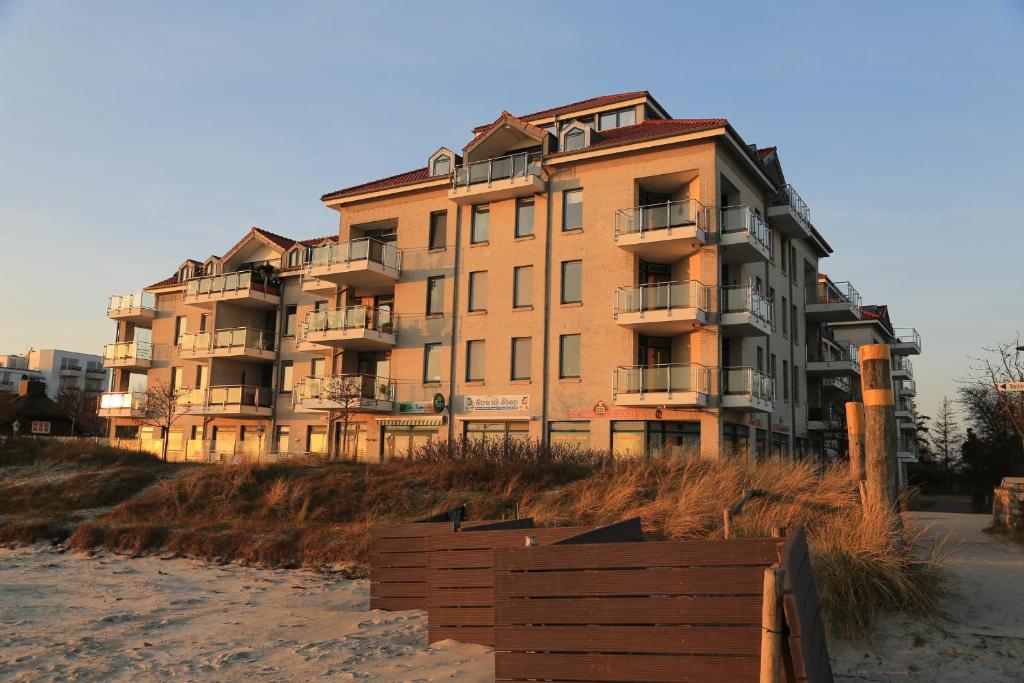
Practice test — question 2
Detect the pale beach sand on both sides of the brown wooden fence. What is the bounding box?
[0,513,1024,683]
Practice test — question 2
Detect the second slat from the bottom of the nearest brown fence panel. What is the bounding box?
[495,625,761,656]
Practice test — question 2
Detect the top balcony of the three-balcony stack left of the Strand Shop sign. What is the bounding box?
[306,238,401,294]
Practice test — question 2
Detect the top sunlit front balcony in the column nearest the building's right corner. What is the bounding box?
[615,200,713,263]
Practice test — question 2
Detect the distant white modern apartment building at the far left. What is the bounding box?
[0,348,109,399]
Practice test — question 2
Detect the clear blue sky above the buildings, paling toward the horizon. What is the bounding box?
[0,0,1024,413]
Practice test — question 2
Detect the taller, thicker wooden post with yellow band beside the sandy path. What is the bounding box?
[860,344,899,510]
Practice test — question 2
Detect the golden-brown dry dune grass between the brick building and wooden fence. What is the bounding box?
[0,442,948,639]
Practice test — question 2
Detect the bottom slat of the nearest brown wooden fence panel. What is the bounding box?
[495,652,759,683]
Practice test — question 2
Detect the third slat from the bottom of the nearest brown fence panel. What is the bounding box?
[496,596,761,625]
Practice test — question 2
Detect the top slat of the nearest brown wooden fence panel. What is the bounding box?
[495,539,777,571]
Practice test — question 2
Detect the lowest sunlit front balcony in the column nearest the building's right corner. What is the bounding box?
[613,364,712,408]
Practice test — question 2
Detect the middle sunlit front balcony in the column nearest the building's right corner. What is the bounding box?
[612,281,713,337]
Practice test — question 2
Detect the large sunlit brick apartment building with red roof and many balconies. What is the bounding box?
[101,91,925,461]
